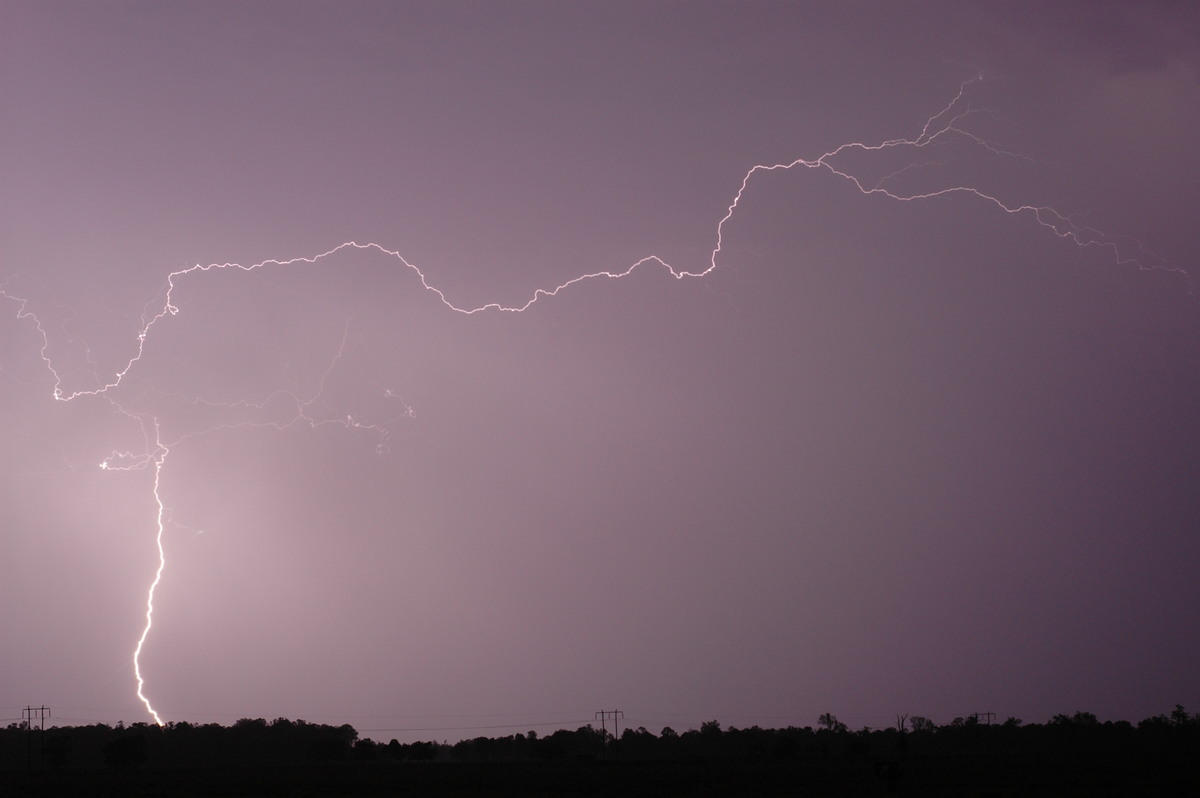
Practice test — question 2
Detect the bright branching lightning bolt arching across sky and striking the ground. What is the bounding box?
[0,78,1192,724]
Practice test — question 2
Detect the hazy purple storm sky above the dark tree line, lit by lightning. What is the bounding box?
[0,0,1200,740]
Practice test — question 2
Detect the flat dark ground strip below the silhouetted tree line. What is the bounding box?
[0,752,1200,798]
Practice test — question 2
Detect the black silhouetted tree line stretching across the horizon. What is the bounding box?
[0,706,1200,780]
